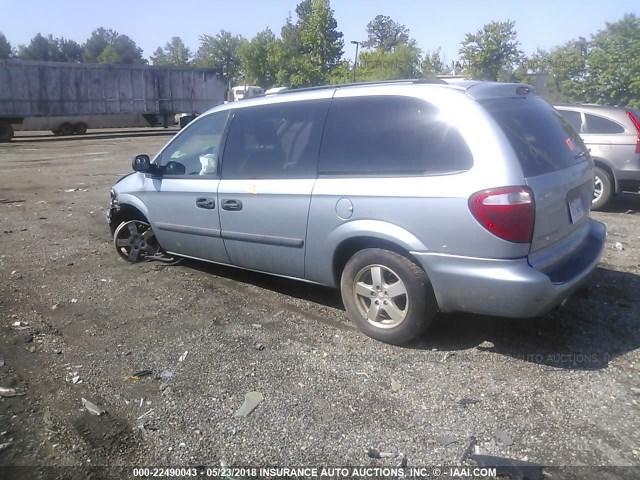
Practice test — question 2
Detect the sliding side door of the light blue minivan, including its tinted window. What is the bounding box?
[218,99,329,278]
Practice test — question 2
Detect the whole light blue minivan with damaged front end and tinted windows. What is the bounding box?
[108,81,605,344]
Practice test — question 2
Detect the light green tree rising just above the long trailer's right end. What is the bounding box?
[195,30,246,83]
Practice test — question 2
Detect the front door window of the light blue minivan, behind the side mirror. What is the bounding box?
[160,112,229,178]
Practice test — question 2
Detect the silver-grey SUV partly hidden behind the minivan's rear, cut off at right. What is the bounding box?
[555,105,640,210]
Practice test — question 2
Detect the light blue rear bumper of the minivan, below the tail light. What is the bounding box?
[411,220,606,318]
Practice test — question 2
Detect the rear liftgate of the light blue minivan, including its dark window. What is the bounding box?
[483,97,594,260]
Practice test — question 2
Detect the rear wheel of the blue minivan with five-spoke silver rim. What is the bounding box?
[340,248,437,345]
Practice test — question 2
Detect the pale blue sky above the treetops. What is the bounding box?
[0,0,640,62]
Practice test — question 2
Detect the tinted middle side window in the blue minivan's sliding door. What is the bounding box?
[222,100,329,179]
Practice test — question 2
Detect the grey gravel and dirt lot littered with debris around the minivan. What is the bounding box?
[0,129,640,478]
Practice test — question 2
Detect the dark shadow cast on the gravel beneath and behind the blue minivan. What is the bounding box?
[179,260,640,370]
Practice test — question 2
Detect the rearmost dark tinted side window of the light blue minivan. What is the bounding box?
[318,96,473,175]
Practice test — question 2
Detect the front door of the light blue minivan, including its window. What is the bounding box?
[139,112,229,263]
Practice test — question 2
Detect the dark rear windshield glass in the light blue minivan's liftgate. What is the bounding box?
[482,97,586,177]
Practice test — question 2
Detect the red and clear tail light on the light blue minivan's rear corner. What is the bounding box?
[469,187,536,243]
